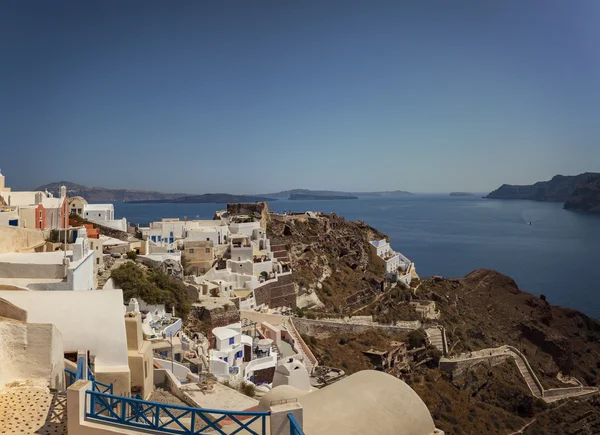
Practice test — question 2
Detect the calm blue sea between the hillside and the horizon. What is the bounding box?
[115,198,600,319]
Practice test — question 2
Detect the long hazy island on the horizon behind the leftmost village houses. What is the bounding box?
[34,181,189,202]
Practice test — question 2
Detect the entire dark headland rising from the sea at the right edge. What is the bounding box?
[484,172,600,213]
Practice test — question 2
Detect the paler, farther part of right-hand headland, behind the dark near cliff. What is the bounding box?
[486,172,600,201]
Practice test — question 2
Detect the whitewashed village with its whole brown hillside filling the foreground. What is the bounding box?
[0,171,600,435]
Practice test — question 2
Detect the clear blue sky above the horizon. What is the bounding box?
[0,0,600,193]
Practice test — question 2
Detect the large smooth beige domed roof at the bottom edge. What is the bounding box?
[300,370,436,435]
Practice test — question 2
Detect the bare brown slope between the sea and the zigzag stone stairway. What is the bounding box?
[419,270,600,388]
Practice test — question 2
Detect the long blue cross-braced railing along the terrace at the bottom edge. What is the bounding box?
[86,390,270,435]
